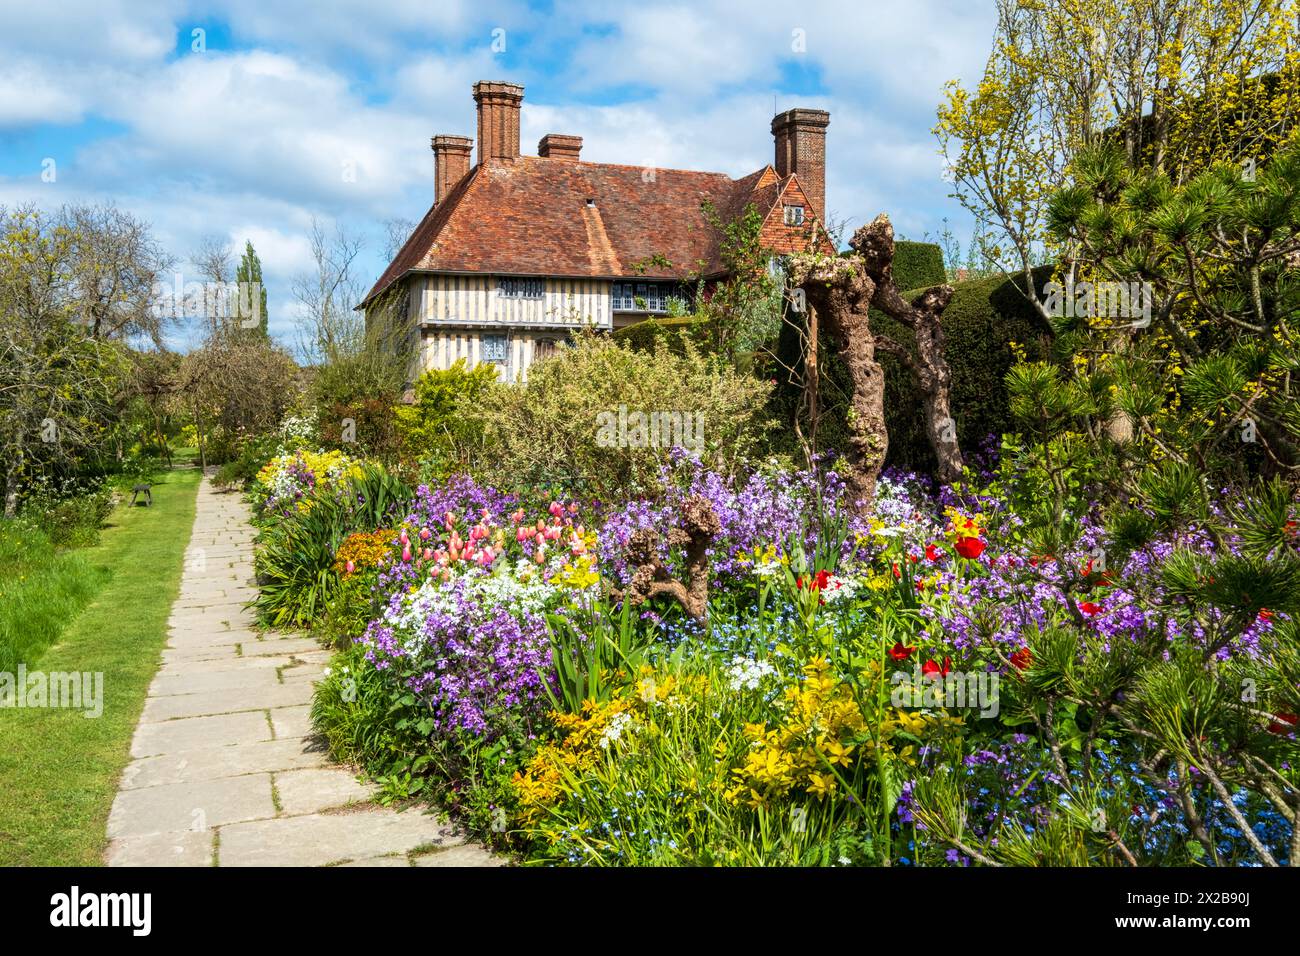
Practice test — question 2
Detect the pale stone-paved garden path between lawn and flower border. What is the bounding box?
[107,470,501,866]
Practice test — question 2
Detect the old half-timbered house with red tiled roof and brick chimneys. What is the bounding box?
[361,82,831,381]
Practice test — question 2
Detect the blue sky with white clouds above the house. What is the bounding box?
[0,0,993,347]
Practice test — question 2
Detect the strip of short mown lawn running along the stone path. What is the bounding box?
[0,470,199,866]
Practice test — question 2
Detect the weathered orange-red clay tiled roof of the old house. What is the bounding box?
[365,156,811,302]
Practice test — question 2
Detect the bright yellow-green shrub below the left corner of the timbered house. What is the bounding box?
[395,359,497,481]
